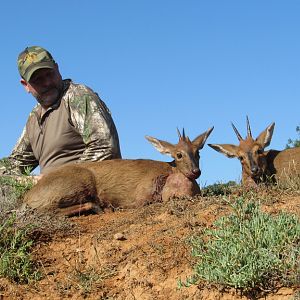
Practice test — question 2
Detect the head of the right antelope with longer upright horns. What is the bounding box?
[209,117,275,184]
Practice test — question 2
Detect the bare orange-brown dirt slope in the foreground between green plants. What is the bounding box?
[0,195,300,300]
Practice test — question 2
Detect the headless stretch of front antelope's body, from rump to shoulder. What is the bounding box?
[24,159,173,214]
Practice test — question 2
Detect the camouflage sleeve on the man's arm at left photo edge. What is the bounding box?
[0,126,38,175]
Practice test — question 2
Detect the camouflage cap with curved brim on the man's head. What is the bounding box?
[18,46,55,82]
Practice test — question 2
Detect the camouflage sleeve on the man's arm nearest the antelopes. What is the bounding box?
[69,89,121,161]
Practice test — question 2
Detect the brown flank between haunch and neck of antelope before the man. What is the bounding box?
[84,159,173,207]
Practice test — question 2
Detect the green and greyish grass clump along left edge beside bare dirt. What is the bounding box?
[0,176,40,283]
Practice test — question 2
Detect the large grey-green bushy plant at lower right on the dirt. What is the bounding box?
[180,198,300,292]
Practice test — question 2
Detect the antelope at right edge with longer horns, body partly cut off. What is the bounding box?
[209,117,300,186]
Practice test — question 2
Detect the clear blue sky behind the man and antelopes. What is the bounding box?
[0,0,300,186]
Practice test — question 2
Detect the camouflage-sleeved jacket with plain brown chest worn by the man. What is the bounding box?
[0,79,121,175]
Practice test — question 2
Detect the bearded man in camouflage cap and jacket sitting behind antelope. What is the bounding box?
[0,46,121,175]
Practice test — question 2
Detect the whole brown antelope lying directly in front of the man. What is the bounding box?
[24,127,213,216]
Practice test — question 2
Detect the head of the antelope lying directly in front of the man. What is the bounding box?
[146,127,214,180]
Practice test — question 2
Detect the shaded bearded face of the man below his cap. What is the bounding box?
[21,66,63,109]
